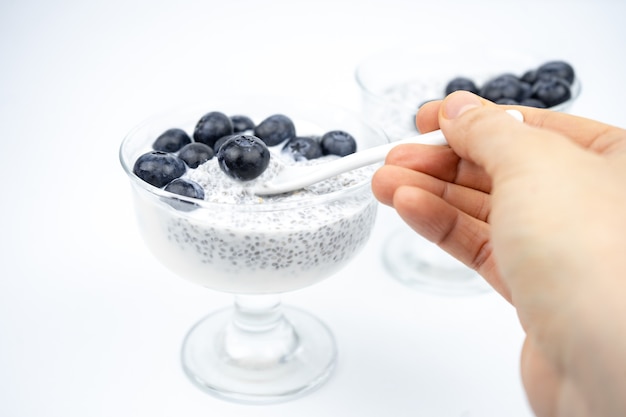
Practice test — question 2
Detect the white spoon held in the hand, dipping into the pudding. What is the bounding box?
[252,110,524,195]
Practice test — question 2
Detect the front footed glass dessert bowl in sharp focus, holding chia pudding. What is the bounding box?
[120,98,386,404]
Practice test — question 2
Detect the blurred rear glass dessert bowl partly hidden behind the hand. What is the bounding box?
[355,45,581,295]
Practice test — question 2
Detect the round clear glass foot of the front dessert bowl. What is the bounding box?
[182,306,337,404]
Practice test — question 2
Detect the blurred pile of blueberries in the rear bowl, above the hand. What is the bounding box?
[445,61,575,108]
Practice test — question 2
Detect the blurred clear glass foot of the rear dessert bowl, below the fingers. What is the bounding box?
[382,227,493,296]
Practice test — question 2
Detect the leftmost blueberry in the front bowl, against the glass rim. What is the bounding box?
[133,151,187,188]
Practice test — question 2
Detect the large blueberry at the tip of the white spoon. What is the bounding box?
[217,135,270,181]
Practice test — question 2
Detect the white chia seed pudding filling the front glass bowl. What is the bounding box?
[127,118,377,294]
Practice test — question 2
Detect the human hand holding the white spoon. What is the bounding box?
[372,92,626,416]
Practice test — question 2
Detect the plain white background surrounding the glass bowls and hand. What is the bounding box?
[0,0,626,417]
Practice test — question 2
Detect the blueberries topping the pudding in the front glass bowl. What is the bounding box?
[133,111,356,199]
